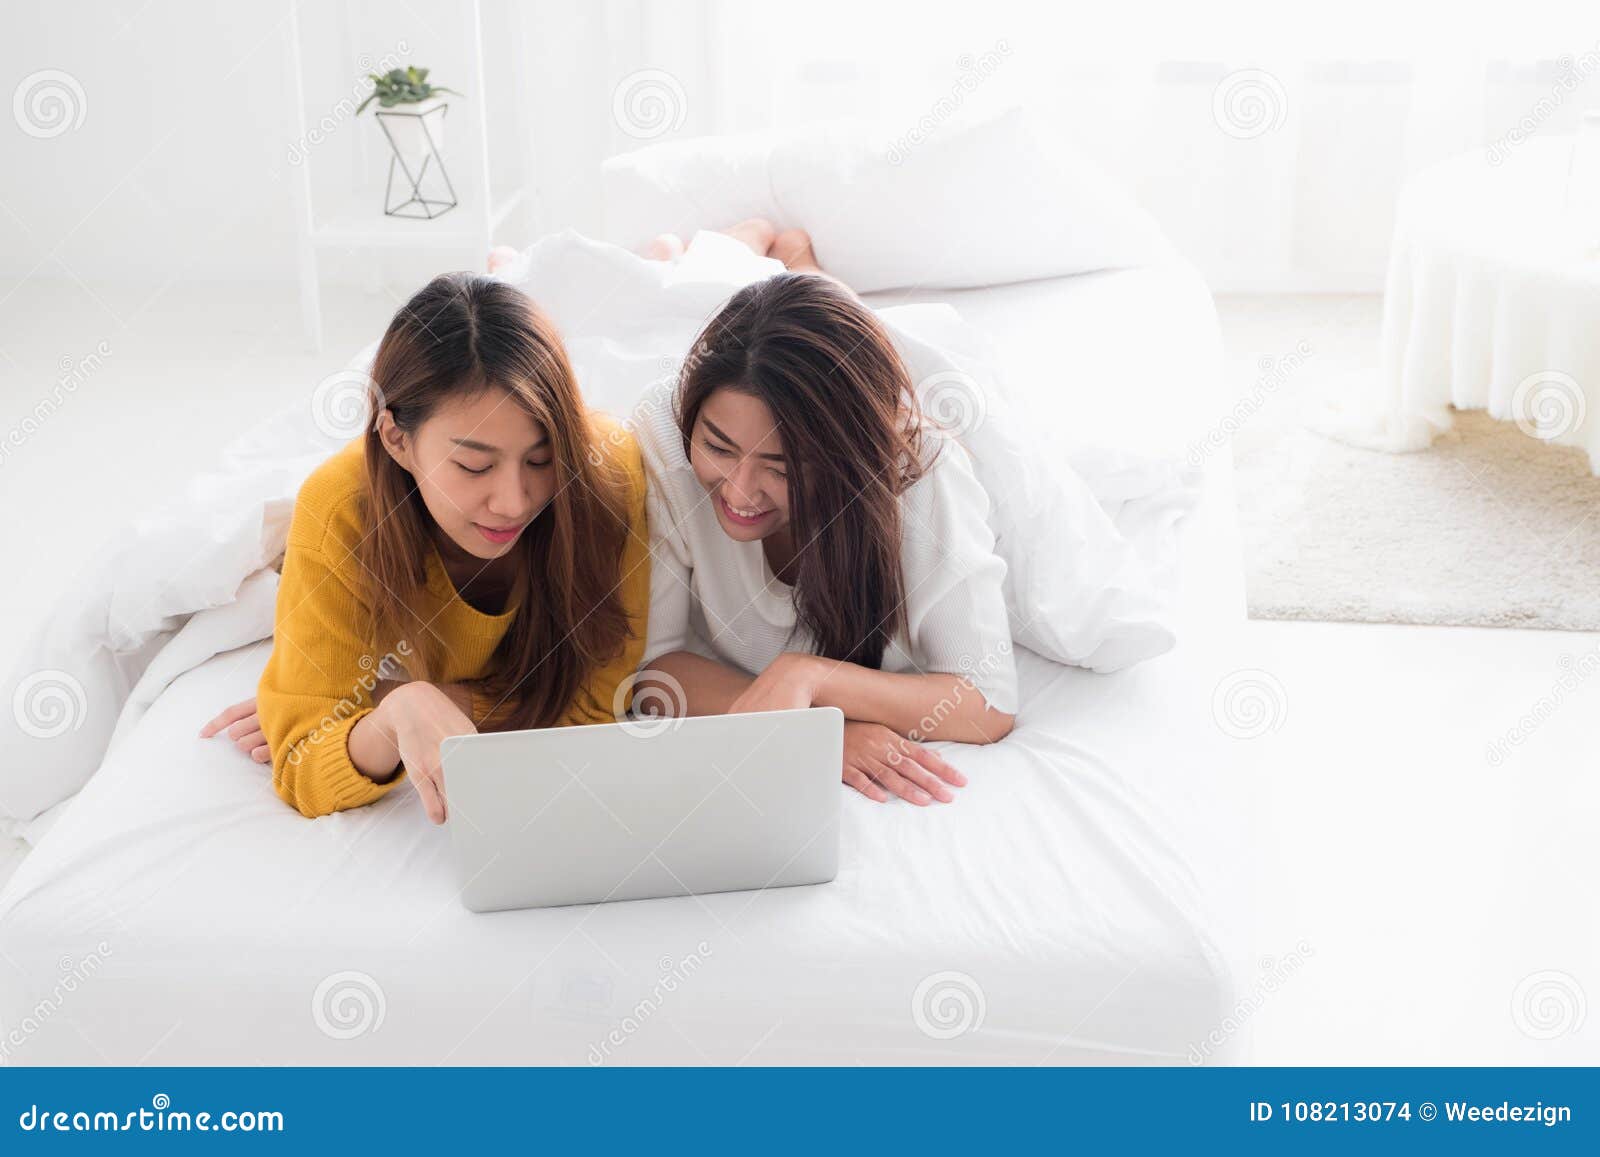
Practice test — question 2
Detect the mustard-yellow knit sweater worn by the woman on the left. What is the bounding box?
[256,414,650,816]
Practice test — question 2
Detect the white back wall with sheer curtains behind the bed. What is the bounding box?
[0,0,1600,299]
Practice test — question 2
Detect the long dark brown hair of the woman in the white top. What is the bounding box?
[677,274,928,667]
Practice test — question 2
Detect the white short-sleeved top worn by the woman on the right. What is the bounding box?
[630,379,1018,714]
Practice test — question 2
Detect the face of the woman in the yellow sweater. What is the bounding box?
[379,389,555,560]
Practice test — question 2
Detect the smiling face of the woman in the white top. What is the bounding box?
[690,387,789,542]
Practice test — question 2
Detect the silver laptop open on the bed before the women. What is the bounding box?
[440,707,845,912]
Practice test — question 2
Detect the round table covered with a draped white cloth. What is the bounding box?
[1342,136,1600,474]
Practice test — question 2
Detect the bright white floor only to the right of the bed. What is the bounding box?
[1218,298,1600,1064]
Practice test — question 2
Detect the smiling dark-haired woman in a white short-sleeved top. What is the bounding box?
[635,264,1018,805]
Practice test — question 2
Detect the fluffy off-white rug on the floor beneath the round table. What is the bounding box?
[1222,299,1600,631]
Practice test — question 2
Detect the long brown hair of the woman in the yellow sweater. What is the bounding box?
[358,274,630,728]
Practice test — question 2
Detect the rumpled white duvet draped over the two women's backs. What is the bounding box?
[0,234,1195,831]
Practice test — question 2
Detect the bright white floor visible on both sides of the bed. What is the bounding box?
[0,282,1600,1064]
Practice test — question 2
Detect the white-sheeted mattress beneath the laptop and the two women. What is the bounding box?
[0,269,1243,1064]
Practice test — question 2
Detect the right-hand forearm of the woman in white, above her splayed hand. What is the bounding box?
[800,655,1016,744]
